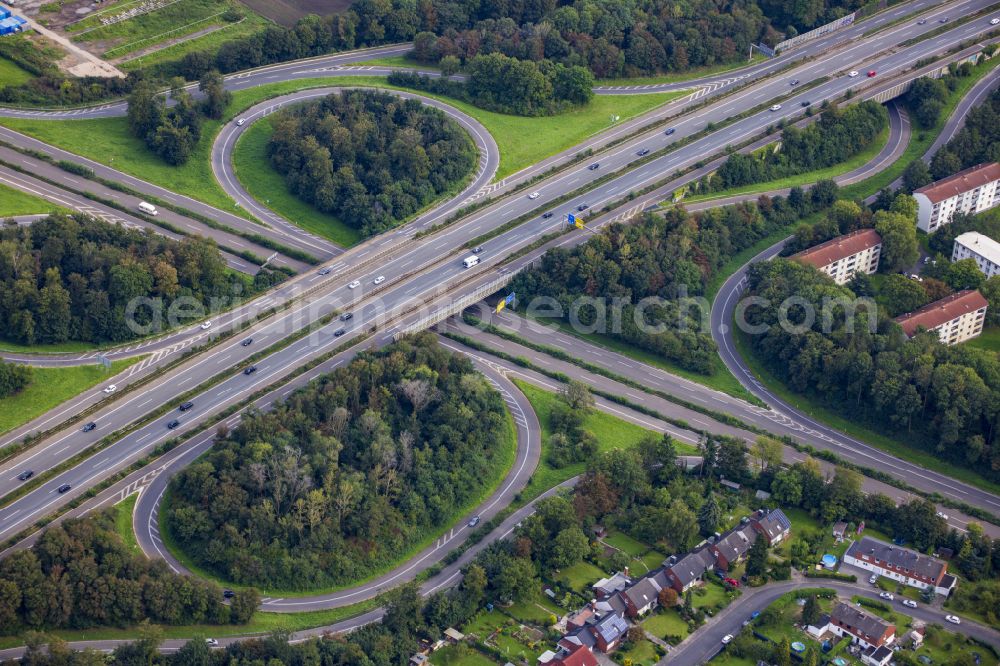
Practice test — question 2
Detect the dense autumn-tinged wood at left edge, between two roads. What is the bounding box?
[0,214,254,345]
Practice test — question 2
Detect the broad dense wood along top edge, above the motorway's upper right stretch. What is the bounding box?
[406,0,861,78]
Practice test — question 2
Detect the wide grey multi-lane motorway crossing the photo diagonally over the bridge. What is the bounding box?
[0,3,1000,652]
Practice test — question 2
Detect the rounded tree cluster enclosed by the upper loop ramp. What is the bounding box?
[267,90,476,235]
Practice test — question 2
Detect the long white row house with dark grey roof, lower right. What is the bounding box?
[844,537,957,596]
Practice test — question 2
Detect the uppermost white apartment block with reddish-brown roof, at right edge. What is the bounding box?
[913,162,1000,233]
